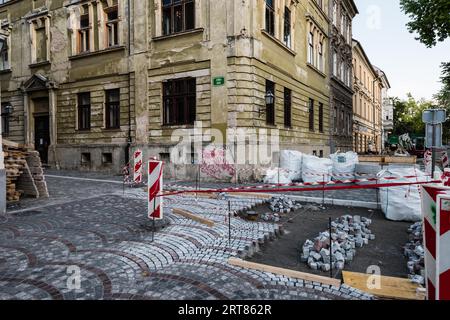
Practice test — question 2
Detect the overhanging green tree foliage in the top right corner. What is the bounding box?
[400,0,450,48]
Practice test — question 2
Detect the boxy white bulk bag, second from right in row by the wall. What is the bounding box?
[302,155,333,183]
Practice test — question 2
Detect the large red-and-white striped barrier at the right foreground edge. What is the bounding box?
[422,185,450,300]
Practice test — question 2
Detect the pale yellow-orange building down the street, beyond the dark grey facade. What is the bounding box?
[353,40,383,153]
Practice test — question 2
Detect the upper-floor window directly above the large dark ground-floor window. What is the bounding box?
[162,0,195,35]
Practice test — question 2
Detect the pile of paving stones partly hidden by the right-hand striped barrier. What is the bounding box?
[405,222,425,285]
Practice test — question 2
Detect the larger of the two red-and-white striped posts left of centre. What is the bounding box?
[148,160,164,220]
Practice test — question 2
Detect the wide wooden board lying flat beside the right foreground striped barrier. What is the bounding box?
[342,271,425,300]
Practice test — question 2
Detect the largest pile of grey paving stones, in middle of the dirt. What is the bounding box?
[300,215,375,271]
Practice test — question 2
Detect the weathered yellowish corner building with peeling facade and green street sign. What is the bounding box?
[0,0,330,176]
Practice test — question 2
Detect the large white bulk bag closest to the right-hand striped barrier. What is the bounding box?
[378,167,429,222]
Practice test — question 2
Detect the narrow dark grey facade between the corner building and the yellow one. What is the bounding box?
[329,0,358,152]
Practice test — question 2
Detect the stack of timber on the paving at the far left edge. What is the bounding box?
[3,140,48,202]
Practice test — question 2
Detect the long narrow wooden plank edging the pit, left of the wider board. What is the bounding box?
[228,258,341,287]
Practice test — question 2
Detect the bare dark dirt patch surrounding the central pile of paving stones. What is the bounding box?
[247,205,412,279]
